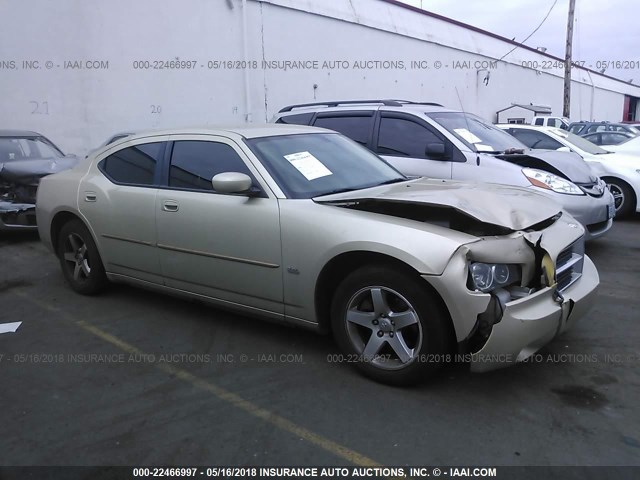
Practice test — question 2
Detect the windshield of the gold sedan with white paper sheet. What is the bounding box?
[247,133,407,198]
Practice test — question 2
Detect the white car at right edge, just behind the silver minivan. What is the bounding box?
[497,125,640,217]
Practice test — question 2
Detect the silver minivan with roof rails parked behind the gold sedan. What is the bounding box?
[272,100,615,240]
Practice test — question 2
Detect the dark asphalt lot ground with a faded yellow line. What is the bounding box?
[0,216,640,465]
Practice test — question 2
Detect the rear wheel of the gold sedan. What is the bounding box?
[58,220,108,295]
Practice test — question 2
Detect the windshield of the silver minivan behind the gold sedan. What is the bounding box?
[426,112,527,153]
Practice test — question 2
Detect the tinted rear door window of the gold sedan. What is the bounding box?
[99,142,165,185]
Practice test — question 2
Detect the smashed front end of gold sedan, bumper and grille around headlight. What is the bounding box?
[423,214,600,372]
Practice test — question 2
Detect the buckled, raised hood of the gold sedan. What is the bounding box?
[314,178,562,231]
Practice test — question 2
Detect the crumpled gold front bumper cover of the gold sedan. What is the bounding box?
[471,256,599,372]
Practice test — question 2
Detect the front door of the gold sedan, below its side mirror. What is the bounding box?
[156,135,284,314]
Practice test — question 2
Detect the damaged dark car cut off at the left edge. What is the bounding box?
[0,130,78,230]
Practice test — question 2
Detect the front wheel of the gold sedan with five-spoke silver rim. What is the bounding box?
[331,266,450,385]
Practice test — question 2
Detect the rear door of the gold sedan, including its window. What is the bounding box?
[78,136,168,284]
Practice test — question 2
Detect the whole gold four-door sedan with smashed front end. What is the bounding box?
[37,125,599,384]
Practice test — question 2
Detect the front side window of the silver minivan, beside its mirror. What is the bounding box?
[378,117,443,158]
